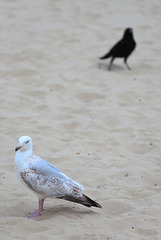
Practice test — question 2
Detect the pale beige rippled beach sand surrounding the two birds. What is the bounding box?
[0,0,161,240]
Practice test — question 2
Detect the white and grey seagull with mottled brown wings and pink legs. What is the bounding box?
[15,136,101,218]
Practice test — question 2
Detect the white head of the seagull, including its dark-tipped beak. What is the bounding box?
[15,136,32,152]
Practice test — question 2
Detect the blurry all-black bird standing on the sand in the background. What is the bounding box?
[100,28,136,71]
